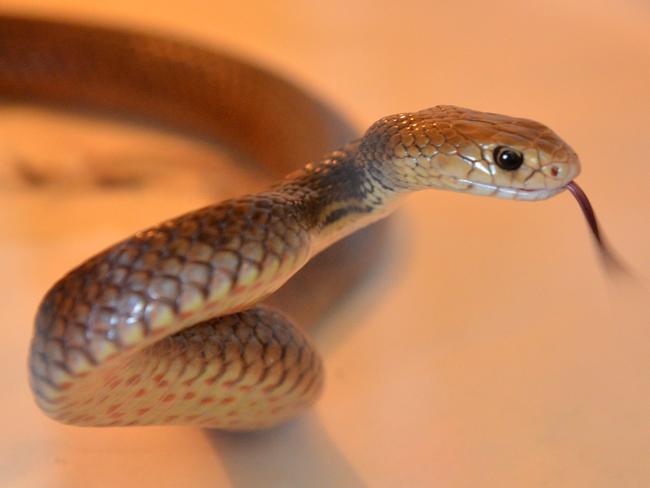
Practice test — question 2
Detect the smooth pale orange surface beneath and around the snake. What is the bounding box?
[0,0,650,488]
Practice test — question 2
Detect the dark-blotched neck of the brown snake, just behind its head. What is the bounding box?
[277,141,403,254]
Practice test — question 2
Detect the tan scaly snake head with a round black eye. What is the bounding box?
[359,105,580,200]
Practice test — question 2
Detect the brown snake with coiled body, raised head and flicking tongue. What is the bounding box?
[0,15,598,431]
